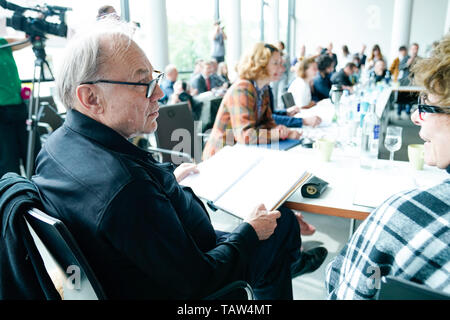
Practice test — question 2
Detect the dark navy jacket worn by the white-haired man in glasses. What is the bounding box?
[33,110,258,299]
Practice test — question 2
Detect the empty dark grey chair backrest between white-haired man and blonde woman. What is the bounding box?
[155,102,201,165]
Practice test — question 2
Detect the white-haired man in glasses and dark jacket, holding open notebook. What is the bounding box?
[33,19,323,299]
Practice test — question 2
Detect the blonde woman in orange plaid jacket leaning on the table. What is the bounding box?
[203,42,300,159]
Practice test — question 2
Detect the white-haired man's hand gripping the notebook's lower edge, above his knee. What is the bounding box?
[244,204,281,240]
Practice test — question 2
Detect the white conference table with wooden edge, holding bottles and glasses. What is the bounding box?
[285,86,448,236]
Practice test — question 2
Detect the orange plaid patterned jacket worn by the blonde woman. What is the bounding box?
[203,79,279,160]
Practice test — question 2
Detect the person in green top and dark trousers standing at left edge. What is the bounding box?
[0,38,41,177]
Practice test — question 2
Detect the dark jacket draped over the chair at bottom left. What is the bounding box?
[0,173,59,300]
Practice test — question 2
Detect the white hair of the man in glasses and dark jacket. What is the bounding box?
[56,18,134,109]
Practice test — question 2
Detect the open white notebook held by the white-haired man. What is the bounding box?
[180,145,311,219]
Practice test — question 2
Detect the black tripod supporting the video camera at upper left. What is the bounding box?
[25,36,55,178]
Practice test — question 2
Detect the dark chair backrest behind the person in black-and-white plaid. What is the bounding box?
[378,276,450,300]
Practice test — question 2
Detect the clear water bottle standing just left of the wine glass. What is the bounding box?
[360,103,380,169]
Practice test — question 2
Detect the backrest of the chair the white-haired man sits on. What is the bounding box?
[25,209,106,300]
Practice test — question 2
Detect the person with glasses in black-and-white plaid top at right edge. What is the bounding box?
[326,33,450,299]
